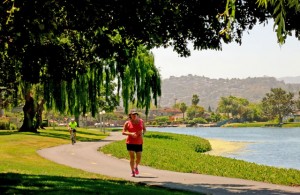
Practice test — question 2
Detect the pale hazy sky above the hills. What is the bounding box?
[152,22,300,79]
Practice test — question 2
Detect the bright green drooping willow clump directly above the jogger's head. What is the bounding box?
[122,46,161,115]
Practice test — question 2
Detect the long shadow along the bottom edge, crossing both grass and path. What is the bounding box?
[0,173,299,195]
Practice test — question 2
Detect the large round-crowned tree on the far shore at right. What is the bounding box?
[262,88,295,123]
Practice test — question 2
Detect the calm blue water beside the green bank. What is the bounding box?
[148,127,300,170]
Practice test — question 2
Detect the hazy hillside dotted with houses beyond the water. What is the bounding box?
[159,75,300,110]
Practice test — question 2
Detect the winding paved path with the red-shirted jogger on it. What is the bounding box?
[38,132,300,195]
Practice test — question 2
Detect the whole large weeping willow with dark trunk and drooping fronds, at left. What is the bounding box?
[0,1,161,132]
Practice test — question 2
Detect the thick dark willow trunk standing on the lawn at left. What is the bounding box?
[19,93,37,133]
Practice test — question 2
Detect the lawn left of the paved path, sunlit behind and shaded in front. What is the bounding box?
[0,128,198,195]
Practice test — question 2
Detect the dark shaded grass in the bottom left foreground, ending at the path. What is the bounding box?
[0,173,197,195]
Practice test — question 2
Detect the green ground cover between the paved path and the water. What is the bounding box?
[101,132,300,186]
